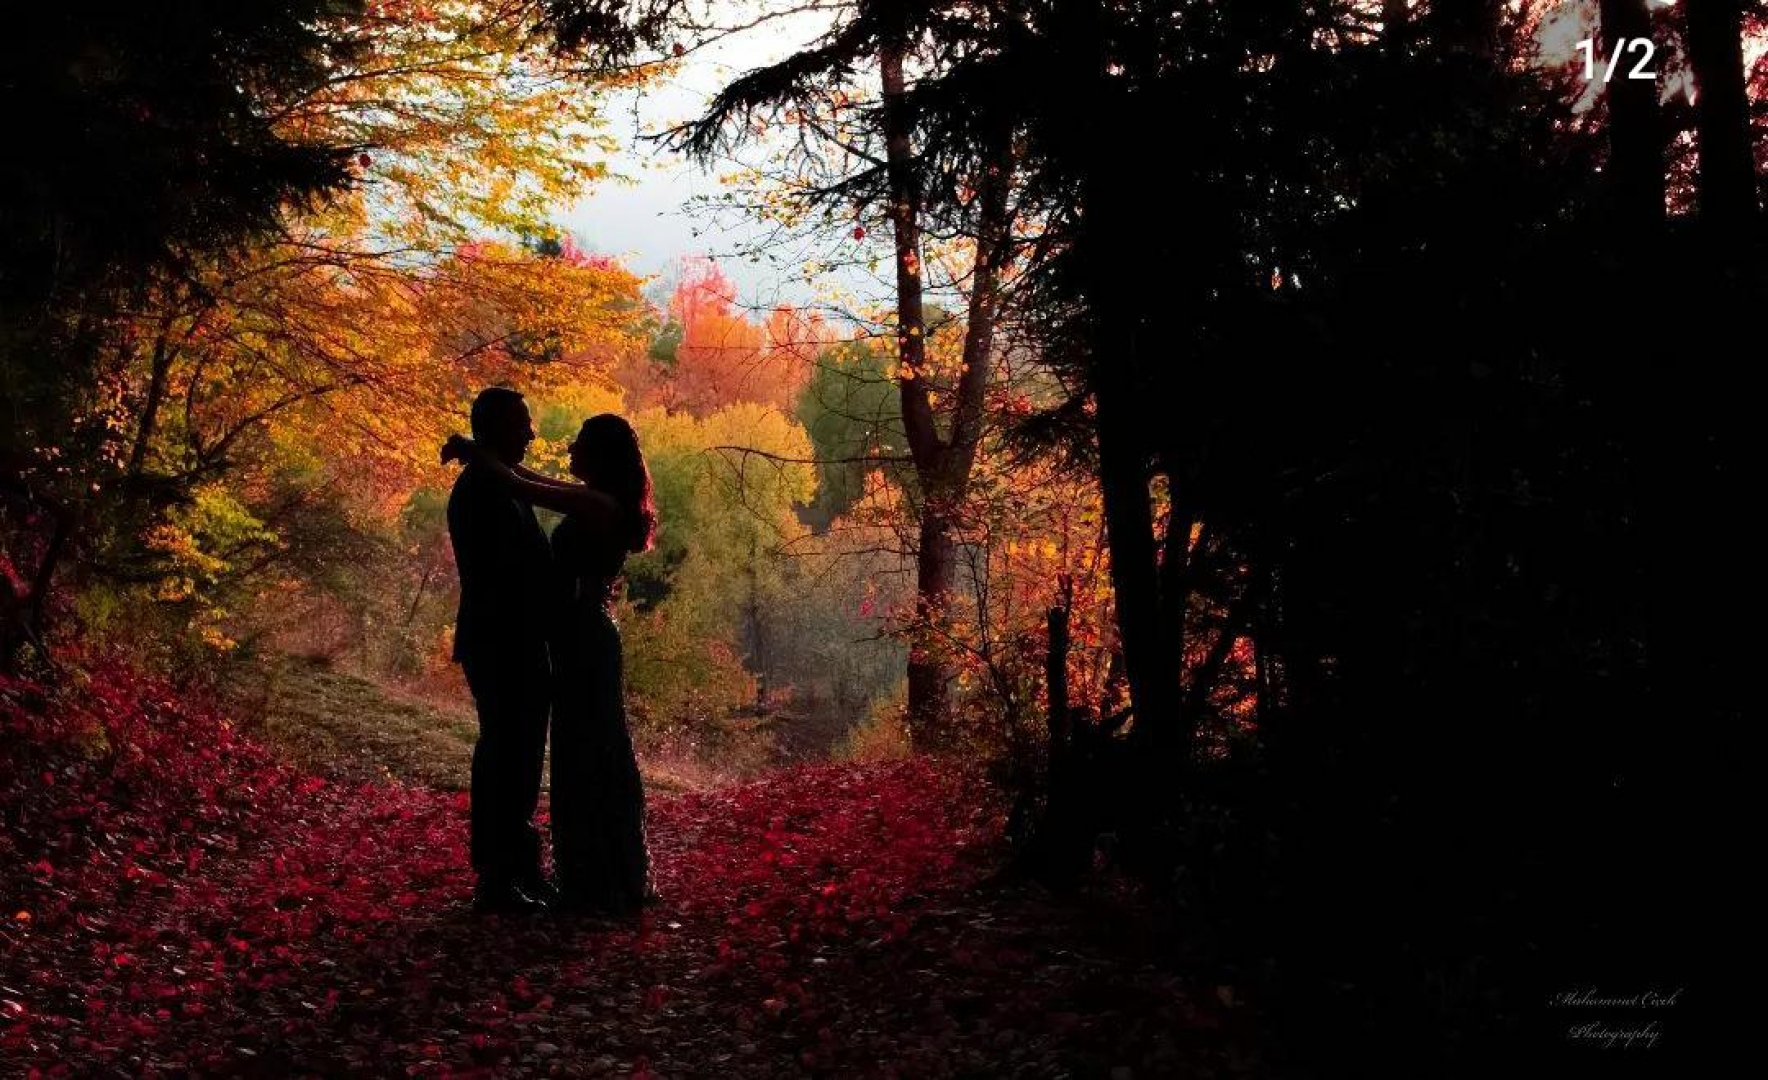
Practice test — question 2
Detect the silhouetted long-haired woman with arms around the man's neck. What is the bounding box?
[444,412,656,916]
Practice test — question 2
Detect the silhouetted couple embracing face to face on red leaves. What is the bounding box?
[442,387,656,916]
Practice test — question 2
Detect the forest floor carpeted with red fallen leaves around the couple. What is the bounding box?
[0,661,1259,1080]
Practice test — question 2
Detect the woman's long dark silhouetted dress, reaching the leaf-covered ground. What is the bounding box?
[552,516,652,916]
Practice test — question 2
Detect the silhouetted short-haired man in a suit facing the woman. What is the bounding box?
[447,387,552,912]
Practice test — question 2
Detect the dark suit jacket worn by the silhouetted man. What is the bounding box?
[447,465,552,663]
